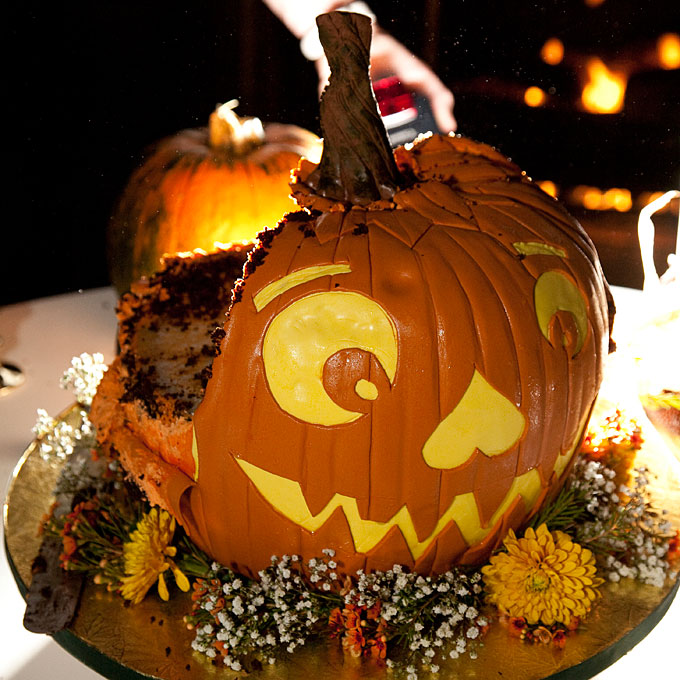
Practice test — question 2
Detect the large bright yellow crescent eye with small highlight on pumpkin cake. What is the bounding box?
[262,291,398,426]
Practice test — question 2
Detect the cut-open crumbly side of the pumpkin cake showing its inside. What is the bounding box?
[91,244,252,509]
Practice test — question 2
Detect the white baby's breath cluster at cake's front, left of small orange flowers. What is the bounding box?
[192,555,337,671]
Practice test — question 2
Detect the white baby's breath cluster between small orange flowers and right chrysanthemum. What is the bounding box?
[345,564,488,680]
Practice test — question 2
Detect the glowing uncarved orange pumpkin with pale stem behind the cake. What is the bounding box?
[109,102,321,293]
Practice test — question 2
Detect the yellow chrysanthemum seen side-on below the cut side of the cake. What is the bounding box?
[120,508,189,604]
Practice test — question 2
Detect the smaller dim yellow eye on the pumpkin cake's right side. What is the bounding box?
[534,271,588,357]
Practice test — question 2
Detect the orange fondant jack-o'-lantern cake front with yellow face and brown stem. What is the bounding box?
[159,13,610,574]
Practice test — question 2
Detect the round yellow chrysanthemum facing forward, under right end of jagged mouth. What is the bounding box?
[482,524,603,626]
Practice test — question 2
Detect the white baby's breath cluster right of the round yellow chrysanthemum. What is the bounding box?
[572,459,672,588]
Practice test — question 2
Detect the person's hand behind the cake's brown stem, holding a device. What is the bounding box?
[315,27,458,133]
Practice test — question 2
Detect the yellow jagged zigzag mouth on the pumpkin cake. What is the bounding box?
[236,458,542,560]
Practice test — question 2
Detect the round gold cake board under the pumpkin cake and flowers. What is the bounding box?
[4,410,680,680]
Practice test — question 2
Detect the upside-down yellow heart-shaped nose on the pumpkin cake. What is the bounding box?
[423,370,524,469]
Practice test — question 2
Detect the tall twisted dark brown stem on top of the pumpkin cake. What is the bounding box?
[305,12,401,205]
